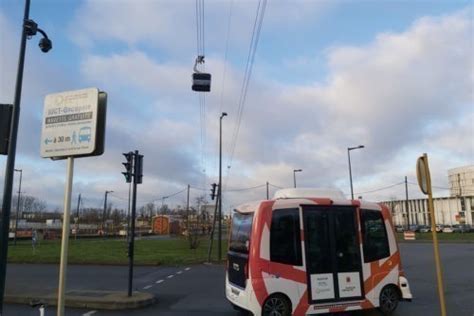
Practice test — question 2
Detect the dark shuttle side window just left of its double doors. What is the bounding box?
[270,209,303,266]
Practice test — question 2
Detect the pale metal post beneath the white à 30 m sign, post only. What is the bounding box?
[57,157,74,316]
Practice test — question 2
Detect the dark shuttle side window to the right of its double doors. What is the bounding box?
[361,210,390,262]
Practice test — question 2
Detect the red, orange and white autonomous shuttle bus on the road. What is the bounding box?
[226,189,412,316]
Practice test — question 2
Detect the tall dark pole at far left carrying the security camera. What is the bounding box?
[0,0,30,316]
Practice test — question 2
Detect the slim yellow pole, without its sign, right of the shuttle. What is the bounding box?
[423,154,446,316]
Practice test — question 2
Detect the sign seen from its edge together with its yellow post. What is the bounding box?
[416,154,446,316]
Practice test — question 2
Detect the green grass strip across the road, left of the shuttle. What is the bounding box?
[8,238,227,265]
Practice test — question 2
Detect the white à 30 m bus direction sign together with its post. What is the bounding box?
[41,88,107,316]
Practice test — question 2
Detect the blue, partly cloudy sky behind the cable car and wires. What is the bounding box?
[0,0,474,212]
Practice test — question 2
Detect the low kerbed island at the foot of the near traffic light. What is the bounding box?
[4,290,156,310]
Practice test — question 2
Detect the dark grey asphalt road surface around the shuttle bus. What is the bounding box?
[4,243,474,316]
